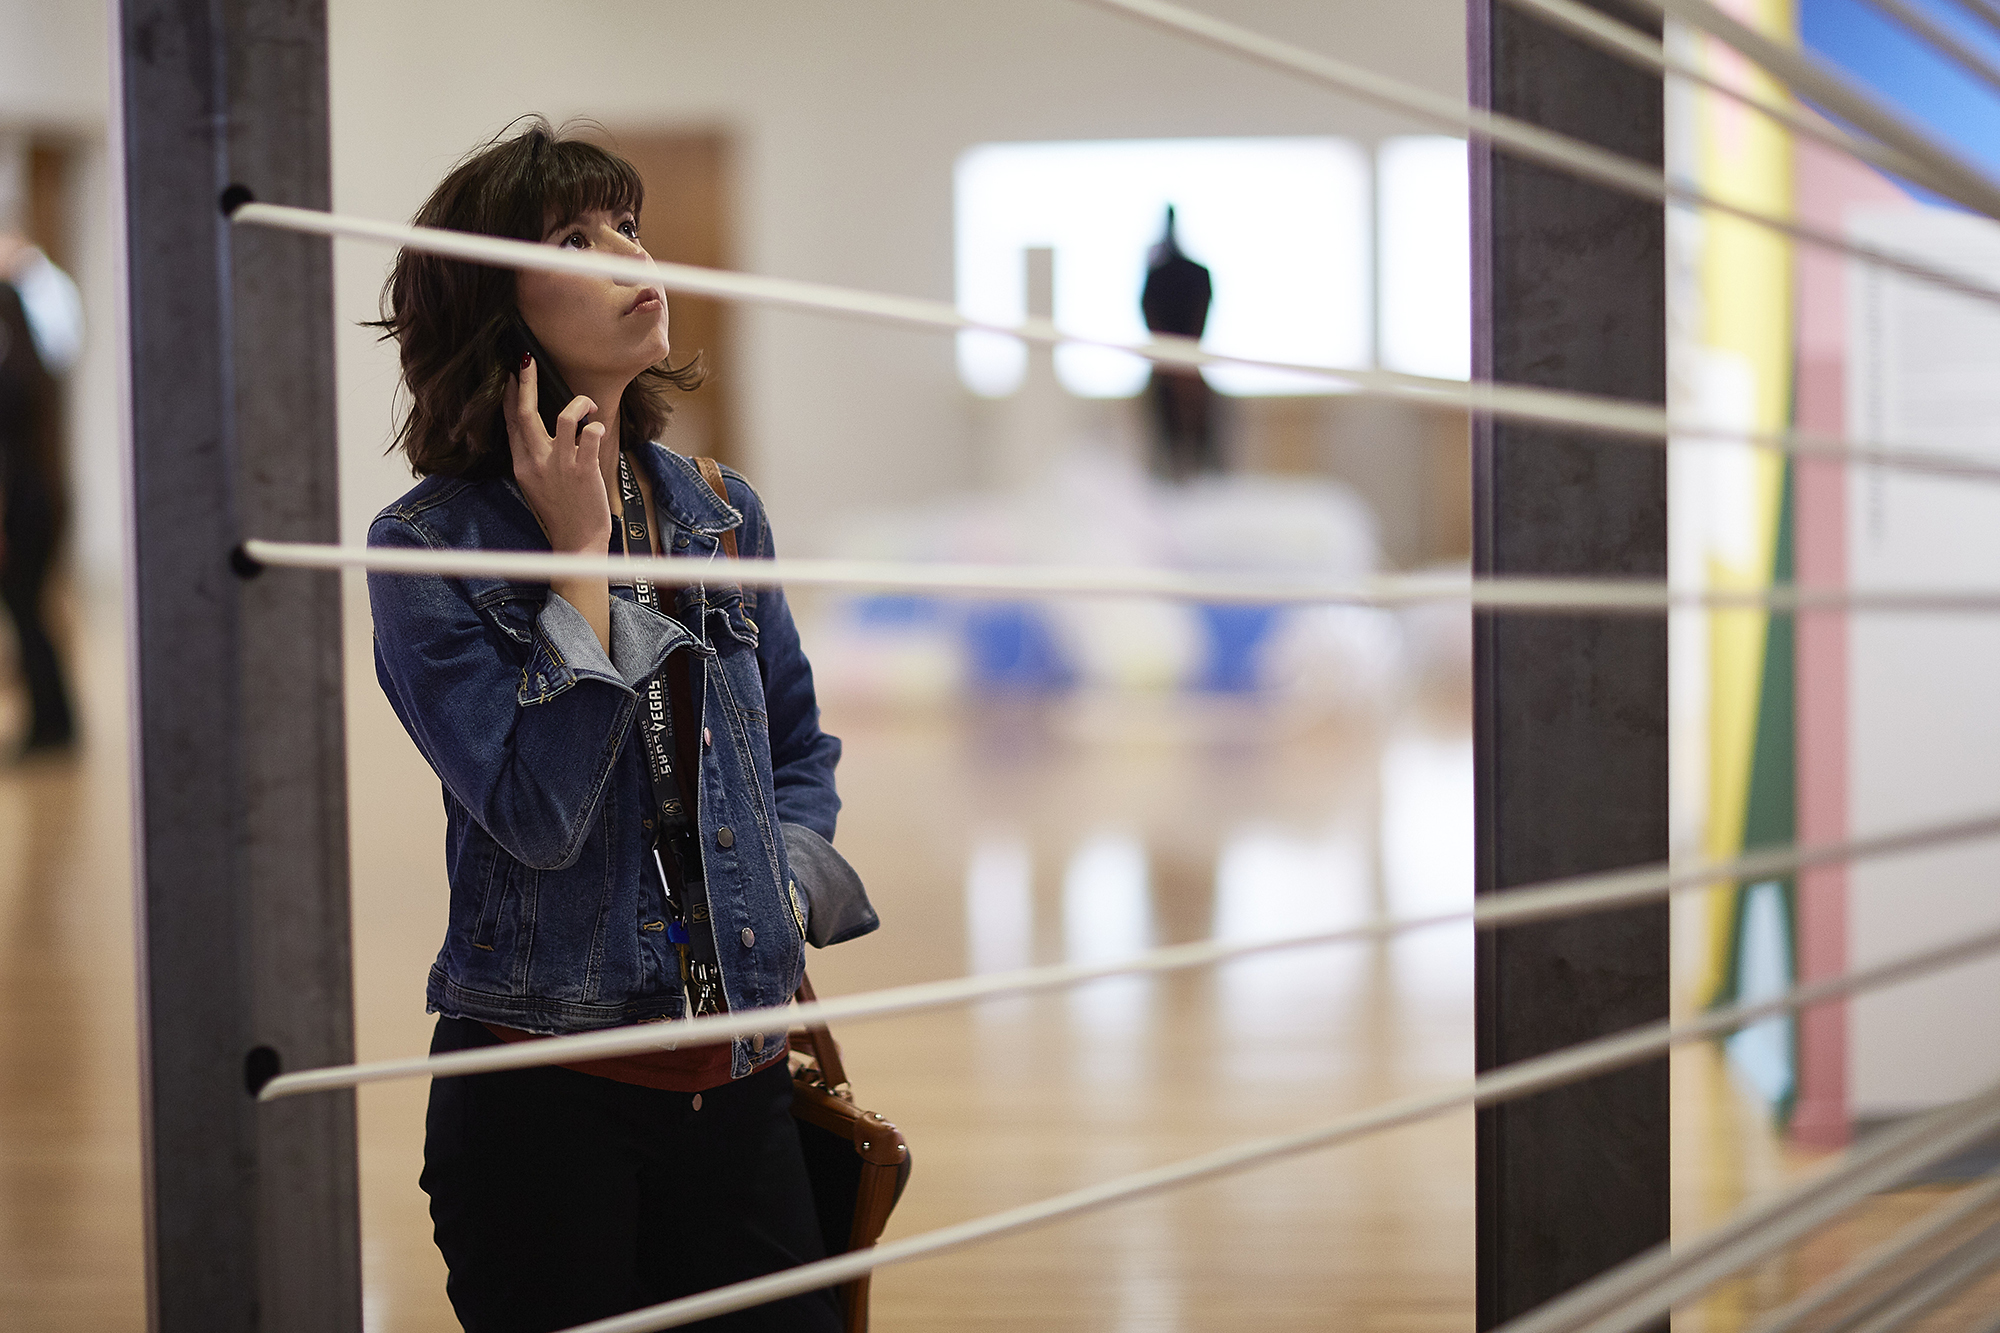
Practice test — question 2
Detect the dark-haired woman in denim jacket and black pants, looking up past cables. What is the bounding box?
[368,118,874,1333]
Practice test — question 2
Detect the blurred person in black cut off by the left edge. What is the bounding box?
[0,232,82,755]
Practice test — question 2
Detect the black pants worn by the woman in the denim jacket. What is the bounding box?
[422,1019,842,1333]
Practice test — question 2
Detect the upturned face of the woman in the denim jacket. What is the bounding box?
[514,208,668,392]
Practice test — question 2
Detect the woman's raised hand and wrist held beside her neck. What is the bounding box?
[504,356,612,652]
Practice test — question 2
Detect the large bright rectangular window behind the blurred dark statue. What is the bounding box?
[956,138,1376,398]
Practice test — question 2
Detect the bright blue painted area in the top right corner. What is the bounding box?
[1798,0,2000,202]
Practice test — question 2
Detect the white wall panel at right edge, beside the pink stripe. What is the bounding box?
[1848,208,2000,1119]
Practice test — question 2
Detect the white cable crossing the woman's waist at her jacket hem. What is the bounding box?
[258,813,2000,1101]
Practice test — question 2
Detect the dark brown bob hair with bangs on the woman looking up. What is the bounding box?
[370,116,702,478]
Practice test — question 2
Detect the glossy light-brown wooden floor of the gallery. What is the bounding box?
[0,584,1990,1333]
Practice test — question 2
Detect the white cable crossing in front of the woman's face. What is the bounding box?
[230,204,2000,480]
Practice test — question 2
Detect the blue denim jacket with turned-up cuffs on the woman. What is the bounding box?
[368,444,844,1077]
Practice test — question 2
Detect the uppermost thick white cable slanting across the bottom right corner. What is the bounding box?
[1500,1087,2000,1333]
